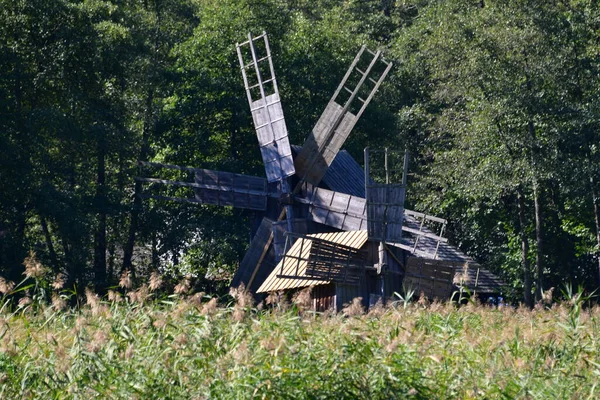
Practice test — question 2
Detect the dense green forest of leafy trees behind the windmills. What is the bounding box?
[0,0,600,305]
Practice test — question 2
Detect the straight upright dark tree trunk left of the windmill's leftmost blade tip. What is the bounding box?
[94,132,106,293]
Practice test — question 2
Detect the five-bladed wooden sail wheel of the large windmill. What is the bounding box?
[136,32,392,287]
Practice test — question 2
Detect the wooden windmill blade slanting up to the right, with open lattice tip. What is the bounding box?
[295,46,392,186]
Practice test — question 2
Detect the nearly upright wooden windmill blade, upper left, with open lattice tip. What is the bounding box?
[236,32,295,183]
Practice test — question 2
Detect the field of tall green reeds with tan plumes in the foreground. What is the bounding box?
[0,282,600,399]
